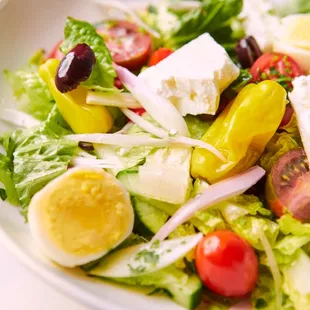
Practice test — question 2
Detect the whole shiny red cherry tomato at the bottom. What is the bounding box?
[196,231,258,297]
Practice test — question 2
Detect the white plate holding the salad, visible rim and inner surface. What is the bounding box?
[0,0,195,310]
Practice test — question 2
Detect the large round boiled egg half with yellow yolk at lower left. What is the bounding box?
[28,167,134,267]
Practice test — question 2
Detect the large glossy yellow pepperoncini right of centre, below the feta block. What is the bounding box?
[191,81,286,183]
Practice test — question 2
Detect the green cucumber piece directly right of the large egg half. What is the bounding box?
[132,197,169,236]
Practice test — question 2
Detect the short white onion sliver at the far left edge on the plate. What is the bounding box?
[0,109,40,128]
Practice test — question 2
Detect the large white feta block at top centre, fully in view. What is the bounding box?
[139,33,239,116]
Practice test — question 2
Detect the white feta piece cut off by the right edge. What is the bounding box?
[289,76,310,160]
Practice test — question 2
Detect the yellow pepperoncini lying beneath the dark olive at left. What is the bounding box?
[39,59,113,133]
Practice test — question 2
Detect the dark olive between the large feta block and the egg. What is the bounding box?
[235,36,263,69]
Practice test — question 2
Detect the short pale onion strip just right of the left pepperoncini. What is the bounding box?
[86,91,141,109]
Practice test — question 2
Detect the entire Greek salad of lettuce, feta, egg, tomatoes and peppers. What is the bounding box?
[0,0,310,310]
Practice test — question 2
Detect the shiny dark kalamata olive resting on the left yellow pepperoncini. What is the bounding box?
[55,44,96,93]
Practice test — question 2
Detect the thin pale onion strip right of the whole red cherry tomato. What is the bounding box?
[257,229,282,309]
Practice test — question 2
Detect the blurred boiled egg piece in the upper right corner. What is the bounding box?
[273,14,310,73]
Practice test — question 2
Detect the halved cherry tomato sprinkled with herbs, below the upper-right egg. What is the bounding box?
[250,53,303,91]
